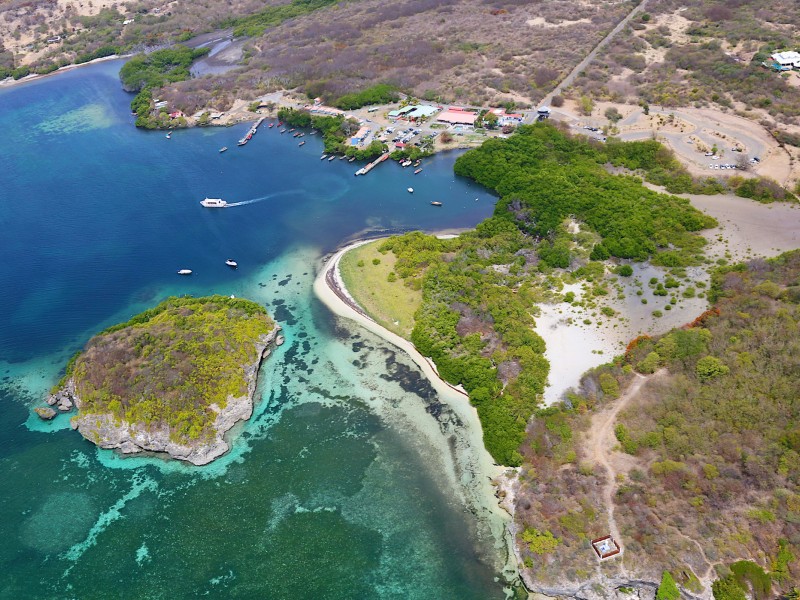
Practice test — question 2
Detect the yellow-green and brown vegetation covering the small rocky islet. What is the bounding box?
[66,296,275,443]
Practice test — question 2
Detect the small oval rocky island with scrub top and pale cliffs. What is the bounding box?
[47,296,280,465]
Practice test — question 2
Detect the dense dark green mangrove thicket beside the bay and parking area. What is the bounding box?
[455,124,716,266]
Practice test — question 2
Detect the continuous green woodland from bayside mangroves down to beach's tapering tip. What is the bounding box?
[346,124,716,465]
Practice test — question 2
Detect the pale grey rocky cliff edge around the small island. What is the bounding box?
[54,326,280,465]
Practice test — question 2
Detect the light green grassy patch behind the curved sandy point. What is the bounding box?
[339,240,422,339]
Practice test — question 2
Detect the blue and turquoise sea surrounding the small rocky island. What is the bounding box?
[0,62,504,599]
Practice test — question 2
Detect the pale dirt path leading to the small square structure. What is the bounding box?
[586,373,648,564]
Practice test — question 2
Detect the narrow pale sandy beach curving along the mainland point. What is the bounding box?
[314,238,524,587]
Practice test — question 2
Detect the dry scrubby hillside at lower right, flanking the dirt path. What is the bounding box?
[517,251,800,600]
